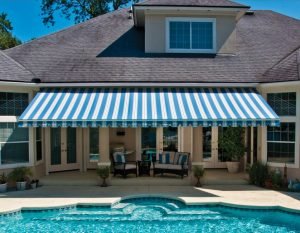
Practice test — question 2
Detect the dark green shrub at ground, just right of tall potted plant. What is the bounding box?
[248,162,269,187]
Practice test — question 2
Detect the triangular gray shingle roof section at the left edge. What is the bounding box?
[0,51,33,82]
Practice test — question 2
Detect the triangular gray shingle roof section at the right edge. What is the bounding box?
[263,47,300,81]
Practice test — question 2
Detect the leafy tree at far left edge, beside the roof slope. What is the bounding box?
[0,13,21,49]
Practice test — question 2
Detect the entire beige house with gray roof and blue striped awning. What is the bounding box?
[0,0,300,181]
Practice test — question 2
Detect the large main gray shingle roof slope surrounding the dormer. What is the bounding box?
[5,9,300,83]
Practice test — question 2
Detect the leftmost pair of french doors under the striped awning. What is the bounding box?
[49,128,79,172]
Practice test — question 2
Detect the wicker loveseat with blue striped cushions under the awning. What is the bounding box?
[153,151,190,178]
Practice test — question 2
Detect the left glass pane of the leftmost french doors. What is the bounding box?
[51,128,61,165]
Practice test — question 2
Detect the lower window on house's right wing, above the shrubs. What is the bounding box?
[267,123,296,163]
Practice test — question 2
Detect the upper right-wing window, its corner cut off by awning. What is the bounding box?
[267,92,296,116]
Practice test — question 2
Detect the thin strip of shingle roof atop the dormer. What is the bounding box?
[135,0,248,8]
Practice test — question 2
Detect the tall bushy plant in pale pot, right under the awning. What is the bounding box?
[219,127,245,173]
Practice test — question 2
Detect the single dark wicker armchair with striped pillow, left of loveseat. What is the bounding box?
[112,152,138,178]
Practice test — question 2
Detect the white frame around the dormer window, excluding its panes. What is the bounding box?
[166,17,217,54]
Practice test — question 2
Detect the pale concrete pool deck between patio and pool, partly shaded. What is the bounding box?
[0,185,300,213]
